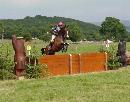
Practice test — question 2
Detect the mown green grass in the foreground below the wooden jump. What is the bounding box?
[0,66,130,102]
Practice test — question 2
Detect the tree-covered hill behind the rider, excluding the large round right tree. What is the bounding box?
[0,15,99,41]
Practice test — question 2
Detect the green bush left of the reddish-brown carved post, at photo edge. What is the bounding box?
[0,45,16,80]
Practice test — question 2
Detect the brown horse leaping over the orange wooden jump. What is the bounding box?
[41,26,68,55]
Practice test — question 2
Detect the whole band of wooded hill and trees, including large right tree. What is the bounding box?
[0,15,130,42]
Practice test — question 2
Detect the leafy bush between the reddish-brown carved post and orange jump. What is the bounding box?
[25,43,49,79]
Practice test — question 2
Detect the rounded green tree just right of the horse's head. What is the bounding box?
[69,23,81,42]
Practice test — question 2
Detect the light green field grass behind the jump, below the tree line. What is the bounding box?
[0,40,130,56]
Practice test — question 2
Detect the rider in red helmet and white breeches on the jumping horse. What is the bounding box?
[50,21,69,46]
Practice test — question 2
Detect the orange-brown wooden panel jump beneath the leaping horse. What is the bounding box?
[39,53,107,76]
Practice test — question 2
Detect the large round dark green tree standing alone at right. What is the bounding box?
[100,17,127,40]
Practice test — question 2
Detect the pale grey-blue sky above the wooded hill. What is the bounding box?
[0,0,130,22]
